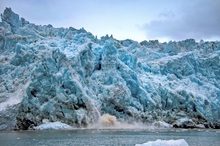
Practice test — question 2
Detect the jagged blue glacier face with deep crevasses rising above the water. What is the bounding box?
[0,8,220,130]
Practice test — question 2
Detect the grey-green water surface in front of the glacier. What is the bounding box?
[0,129,220,146]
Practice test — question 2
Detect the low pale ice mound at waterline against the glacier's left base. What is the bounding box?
[33,122,73,130]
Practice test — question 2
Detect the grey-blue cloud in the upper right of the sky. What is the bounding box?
[143,0,220,40]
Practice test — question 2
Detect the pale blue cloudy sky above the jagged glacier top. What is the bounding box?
[0,0,220,42]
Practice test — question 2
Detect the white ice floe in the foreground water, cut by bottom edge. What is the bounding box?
[135,139,189,146]
